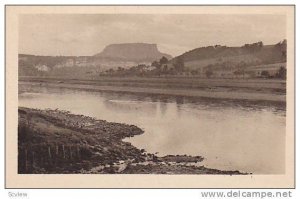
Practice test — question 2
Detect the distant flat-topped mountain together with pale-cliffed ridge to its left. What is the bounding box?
[19,43,171,76]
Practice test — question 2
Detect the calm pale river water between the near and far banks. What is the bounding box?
[19,85,285,174]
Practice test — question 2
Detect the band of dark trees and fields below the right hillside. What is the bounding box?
[100,57,286,79]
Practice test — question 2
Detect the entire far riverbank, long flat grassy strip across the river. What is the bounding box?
[19,77,286,104]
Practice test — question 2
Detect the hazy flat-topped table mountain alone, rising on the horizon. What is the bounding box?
[95,43,171,62]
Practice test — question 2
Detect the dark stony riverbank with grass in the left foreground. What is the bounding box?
[18,107,242,175]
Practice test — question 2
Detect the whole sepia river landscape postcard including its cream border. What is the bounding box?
[6,6,294,187]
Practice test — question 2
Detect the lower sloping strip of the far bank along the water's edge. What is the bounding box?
[19,81,286,103]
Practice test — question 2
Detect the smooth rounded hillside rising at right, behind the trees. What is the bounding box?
[170,40,286,71]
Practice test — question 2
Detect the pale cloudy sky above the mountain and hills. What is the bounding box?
[19,14,286,56]
